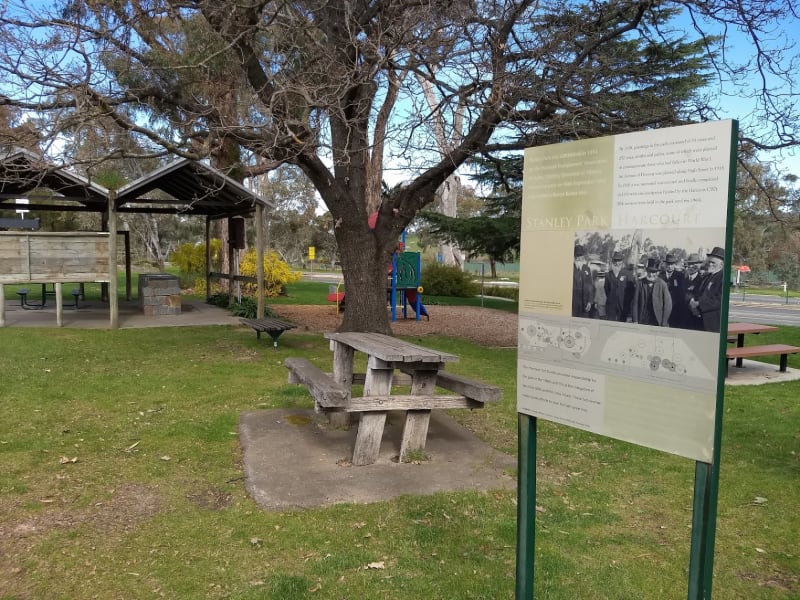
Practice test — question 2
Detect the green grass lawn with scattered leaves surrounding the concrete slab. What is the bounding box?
[0,318,800,600]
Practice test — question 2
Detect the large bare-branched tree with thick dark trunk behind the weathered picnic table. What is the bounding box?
[0,0,797,332]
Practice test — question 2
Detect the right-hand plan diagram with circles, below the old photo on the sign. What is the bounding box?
[601,331,713,378]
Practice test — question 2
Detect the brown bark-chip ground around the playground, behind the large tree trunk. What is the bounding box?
[271,304,517,348]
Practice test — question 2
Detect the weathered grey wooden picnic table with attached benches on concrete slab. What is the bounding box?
[284,332,502,465]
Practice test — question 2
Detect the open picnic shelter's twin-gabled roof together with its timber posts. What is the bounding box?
[0,149,273,329]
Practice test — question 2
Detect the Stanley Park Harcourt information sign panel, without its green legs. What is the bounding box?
[517,121,735,463]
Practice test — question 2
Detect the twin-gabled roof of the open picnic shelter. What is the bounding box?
[0,150,273,218]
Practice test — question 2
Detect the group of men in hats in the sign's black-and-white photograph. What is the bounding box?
[572,244,725,332]
